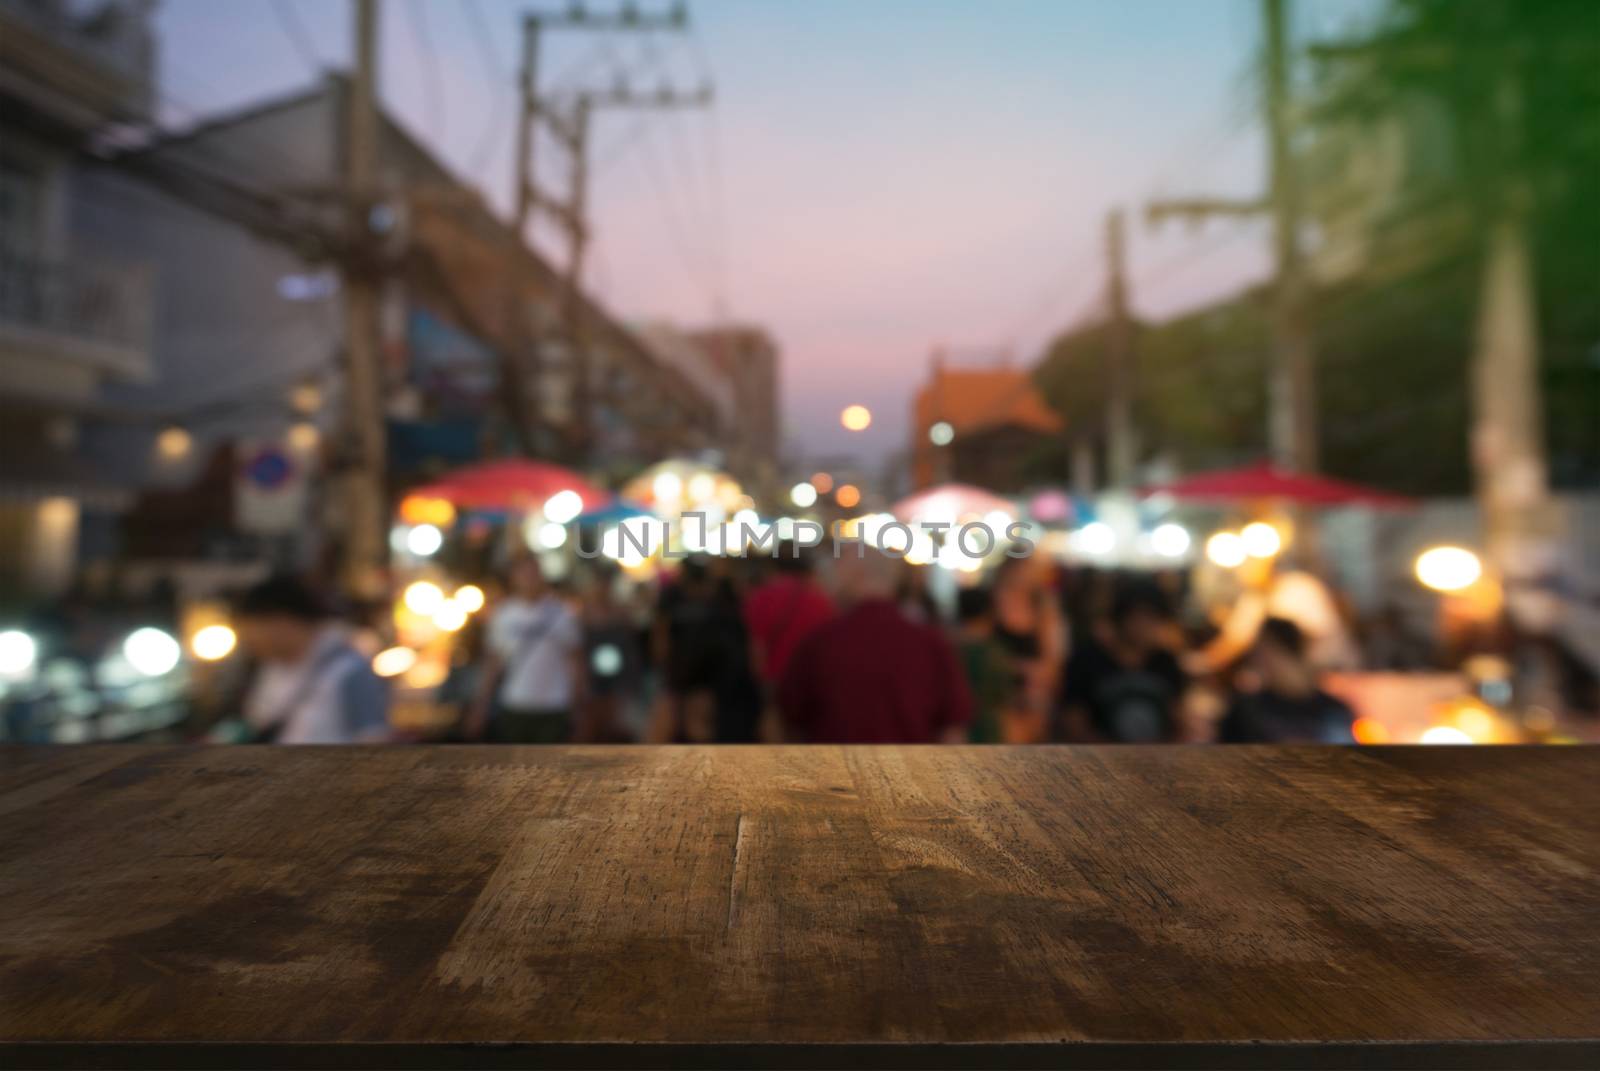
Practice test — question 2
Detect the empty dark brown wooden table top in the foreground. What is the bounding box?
[0,746,1600,1068]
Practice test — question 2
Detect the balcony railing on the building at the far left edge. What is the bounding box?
[0,250,150,355]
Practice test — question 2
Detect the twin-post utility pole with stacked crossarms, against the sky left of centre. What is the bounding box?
[507,0,688,458]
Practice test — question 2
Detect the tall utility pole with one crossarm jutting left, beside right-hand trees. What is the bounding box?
[1147,0,1318,472]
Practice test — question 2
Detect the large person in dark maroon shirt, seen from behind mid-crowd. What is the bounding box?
[778,548,973,744]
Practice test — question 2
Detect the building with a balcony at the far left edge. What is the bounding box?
[0,0,155,602]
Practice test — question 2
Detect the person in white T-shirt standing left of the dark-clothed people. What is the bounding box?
[466,557,584,744]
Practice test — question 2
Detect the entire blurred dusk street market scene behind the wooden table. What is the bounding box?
[0,0,1600,744]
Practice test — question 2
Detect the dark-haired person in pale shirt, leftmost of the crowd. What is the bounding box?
[234,576,389,744]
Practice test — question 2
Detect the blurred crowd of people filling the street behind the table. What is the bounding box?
[225,544,1376,743]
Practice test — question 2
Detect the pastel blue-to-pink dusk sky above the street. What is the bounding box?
[158,0,1371,461]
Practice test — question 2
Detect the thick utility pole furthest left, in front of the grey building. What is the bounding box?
[341,0,389,596]
